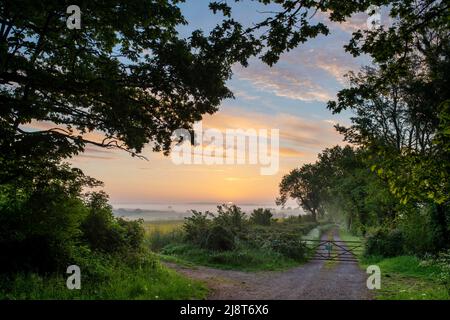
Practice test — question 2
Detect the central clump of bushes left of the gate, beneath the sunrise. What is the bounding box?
[169,206,317,266]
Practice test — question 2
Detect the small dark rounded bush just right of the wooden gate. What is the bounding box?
[365,229,405,257]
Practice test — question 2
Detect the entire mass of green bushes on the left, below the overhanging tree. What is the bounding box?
[0,166,145,274]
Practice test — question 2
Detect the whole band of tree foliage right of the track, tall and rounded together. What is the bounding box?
[280,1,450,251]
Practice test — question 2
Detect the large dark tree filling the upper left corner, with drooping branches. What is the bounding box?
[0,0,260,165]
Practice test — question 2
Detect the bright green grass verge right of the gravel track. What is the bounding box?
[339,229,450,300]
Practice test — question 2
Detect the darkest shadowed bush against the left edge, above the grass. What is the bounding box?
[0,182,88,273]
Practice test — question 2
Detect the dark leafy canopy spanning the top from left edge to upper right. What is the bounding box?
[0,0,447,165]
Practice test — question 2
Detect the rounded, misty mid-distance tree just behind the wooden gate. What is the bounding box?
[278,146,400,234]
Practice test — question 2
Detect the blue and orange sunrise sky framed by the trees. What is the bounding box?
[67,1,378,204]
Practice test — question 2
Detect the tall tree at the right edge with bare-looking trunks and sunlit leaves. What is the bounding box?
[328,1,450,247]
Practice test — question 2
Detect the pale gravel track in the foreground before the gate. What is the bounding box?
[167,230,371,300]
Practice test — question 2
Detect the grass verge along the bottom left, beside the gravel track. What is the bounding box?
[0,263,207,300]
